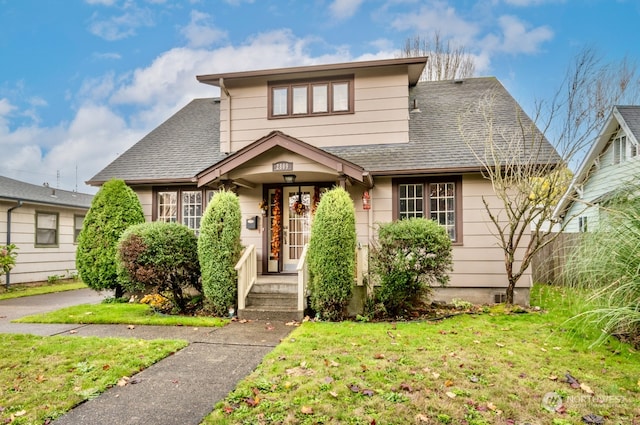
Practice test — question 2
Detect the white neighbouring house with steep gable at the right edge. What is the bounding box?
[554,106,640,233]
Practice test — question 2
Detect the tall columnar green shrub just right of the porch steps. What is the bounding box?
[307,188,356,320]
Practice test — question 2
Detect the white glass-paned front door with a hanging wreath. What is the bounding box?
[282,186,314,272]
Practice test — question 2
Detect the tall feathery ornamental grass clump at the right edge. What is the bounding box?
[563,193,640,345]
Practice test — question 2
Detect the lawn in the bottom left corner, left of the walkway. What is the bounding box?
[0,334,187,425]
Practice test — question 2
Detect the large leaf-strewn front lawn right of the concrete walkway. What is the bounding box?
[204,286,640,425]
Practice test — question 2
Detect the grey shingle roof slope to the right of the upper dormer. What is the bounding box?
[326,77,560,174]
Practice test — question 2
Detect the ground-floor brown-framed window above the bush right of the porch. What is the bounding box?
[394,178,462,243]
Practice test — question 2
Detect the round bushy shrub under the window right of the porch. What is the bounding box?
[369,218,452,316]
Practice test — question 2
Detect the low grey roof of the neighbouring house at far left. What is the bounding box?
[0,176,93,209]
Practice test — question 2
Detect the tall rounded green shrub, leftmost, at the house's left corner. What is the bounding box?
[76,179,144,298]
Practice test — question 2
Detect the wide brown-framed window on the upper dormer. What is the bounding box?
[269,75,353,118]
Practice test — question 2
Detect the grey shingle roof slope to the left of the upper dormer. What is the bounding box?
[87,99,227,184]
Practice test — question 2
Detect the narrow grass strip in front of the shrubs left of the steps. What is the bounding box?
[14,303,229,327]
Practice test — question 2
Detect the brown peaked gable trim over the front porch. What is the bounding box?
[196,130,372,187]
